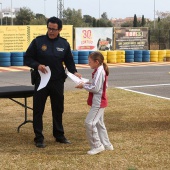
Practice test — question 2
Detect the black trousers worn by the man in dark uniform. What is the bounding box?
[33,79,64,142]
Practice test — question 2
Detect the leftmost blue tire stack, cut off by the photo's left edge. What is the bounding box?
[0,52,11,67]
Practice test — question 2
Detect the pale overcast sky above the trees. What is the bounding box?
[0,0,170,20]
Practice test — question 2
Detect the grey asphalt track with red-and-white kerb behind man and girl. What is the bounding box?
[0,62,170,100]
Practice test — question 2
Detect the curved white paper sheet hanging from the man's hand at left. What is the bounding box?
[37,66,51,91]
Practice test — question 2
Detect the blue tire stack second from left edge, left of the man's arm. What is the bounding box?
[11,52,24,66]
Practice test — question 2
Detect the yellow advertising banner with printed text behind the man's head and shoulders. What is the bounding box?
[0,25,73,52]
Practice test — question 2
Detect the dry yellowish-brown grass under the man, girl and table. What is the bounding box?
[0,88,170,170]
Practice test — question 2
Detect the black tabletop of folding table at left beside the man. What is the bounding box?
[0,86,34,98]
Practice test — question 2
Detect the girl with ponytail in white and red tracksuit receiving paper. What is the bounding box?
[76,52,113,155]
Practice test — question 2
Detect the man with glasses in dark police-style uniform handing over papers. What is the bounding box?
[24,17,81,148]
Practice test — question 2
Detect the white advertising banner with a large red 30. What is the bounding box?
[75,27,113,51]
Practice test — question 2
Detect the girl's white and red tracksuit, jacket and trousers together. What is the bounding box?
[83,65,111,149]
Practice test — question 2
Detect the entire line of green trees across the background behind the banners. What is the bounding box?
[2,7,170,48]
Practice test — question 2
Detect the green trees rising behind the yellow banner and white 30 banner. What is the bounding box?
[2,7,113,27]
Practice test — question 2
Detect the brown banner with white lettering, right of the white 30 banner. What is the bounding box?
[114,27,148,50]
